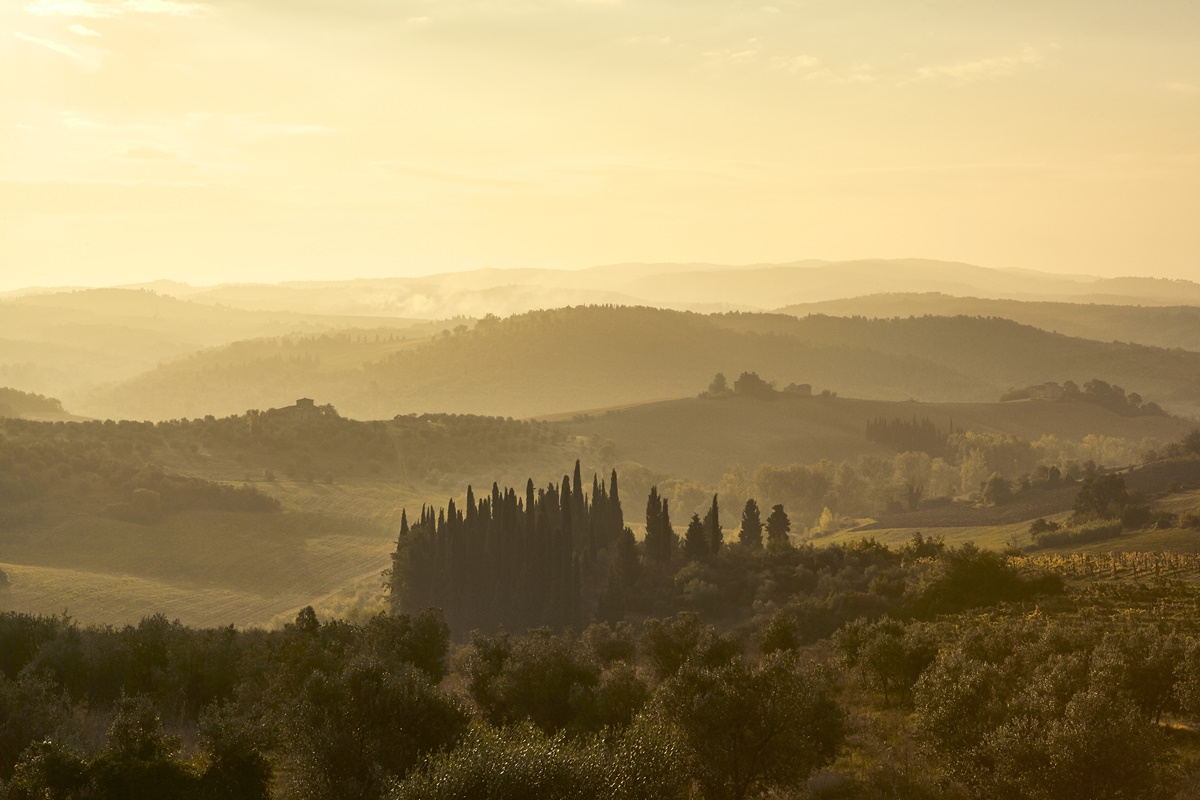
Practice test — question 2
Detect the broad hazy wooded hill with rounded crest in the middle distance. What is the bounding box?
[82,306,984,419]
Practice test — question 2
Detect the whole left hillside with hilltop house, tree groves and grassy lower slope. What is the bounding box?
[0,408,598,626]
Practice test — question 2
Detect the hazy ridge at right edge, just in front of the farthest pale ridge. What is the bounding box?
[779,293,1200,350]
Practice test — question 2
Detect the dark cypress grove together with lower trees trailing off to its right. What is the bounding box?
[385,462,1058,639]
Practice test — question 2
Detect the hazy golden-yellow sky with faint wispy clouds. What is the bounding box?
[0,0,1200,287]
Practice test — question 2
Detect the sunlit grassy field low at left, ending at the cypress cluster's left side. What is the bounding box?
[0,481,430,626]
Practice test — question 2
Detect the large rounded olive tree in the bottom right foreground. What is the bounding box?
[916,621,1174,800]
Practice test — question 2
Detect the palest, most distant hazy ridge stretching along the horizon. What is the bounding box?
[129,259,1200,318]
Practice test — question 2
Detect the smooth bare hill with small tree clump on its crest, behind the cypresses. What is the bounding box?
[556,393,1193,482]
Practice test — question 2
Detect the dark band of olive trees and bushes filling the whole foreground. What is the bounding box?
[0,573,1200,800]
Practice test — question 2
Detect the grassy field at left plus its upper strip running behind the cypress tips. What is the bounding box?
[0,422,600,626]
